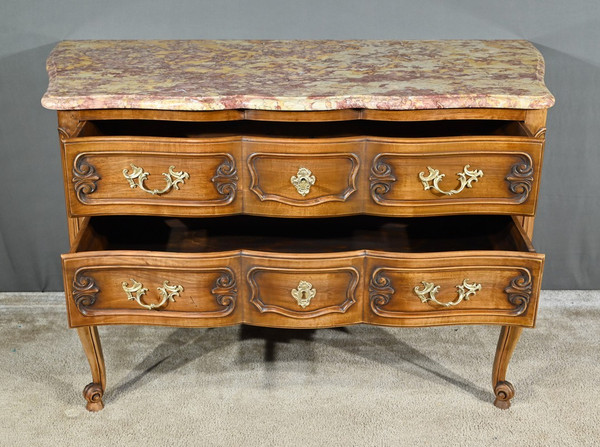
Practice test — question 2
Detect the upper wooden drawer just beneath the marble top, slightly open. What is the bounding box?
[64,120,544,217]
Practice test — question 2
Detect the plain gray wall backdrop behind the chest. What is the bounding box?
[0,0,600,291]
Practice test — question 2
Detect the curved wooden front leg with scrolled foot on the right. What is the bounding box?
[492,326,523,410]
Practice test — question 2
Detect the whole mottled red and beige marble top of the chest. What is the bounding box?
[42,40,554,110]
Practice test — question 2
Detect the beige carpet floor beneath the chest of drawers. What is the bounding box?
[0,291,600,446]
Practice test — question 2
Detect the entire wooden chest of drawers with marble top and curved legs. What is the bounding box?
[42,41,554,411]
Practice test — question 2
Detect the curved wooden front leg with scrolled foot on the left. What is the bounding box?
[77,326,106,411]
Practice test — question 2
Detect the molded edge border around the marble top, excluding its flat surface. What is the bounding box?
[42,40,555,111]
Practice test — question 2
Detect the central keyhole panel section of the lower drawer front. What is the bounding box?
[243,255,363,328]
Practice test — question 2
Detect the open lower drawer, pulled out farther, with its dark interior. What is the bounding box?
[63,216,544,328]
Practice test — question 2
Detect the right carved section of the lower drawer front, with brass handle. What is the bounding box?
[365,252,544,327]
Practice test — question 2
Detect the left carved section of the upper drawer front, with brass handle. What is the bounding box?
[64,138,242,216]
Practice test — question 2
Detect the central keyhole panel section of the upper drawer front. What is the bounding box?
[244,140,364,216]
